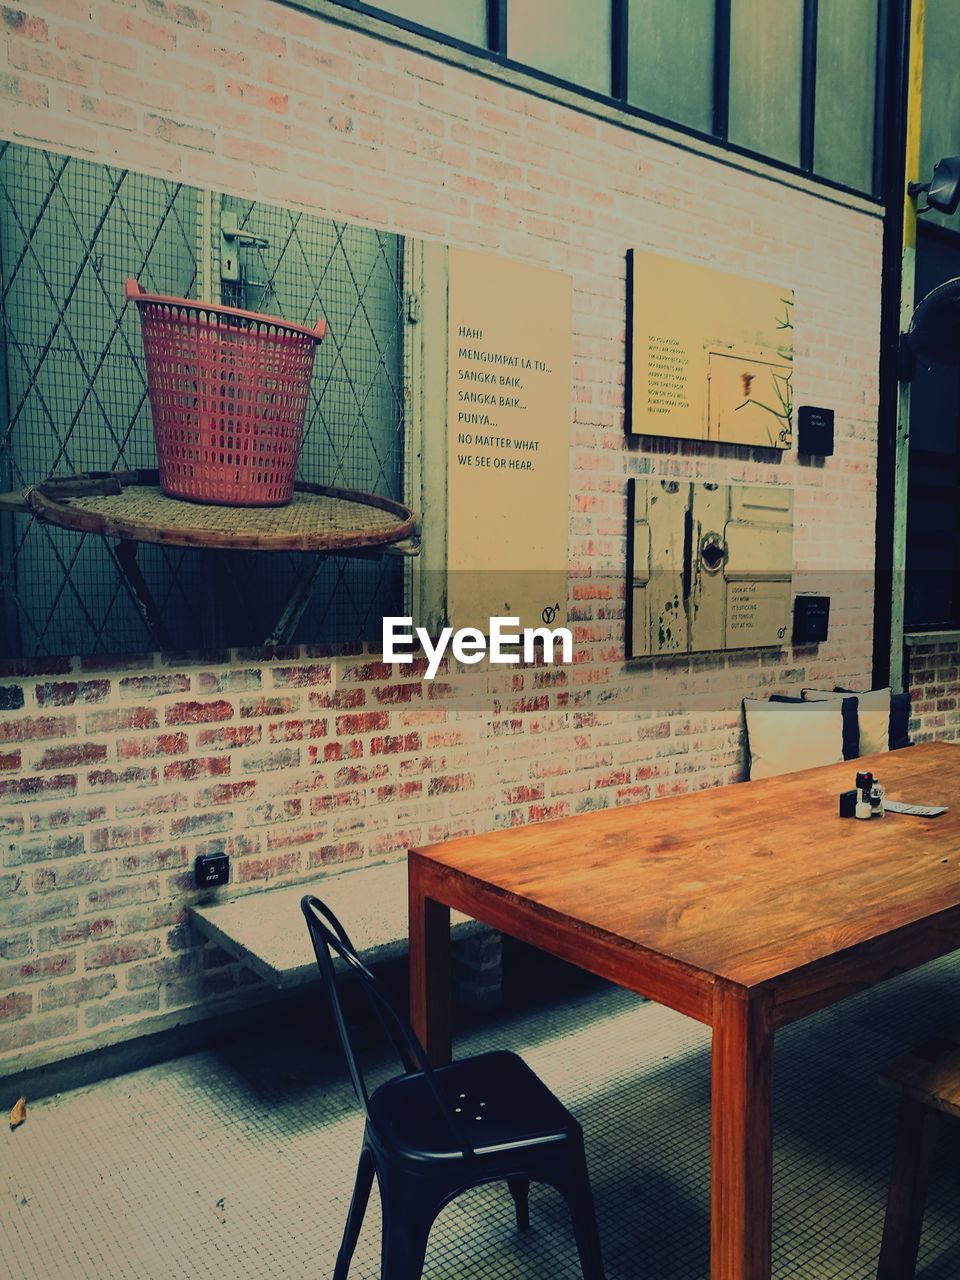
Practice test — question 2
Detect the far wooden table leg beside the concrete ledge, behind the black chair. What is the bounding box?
[408,859,452,1066]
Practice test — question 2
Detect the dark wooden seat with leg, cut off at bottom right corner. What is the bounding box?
[877,1032,960,1280]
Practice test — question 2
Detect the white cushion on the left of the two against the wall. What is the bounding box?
[744,698,844,782]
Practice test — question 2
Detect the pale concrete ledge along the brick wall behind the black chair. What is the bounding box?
[189,859,485,989]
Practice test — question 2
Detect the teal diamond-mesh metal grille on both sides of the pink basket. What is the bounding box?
[0,143,403,657]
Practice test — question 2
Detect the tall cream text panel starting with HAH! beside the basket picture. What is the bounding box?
[447,248,572,631]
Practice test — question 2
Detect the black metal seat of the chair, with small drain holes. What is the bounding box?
[370,1052,579,1160]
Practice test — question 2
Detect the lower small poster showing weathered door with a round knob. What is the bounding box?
[626,477,794,658]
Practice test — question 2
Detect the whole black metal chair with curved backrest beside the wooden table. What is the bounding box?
[301,896,603,1280]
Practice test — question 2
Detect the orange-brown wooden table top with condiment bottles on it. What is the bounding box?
[411,742,960,988]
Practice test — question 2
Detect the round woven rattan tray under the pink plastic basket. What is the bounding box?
[17,471,413,553]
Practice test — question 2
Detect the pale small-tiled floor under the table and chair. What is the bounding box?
[0,960,960,1280]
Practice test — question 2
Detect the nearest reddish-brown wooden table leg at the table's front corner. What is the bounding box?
[710,983,773,1280]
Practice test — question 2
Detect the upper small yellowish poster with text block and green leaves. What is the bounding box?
[627,250,794,449]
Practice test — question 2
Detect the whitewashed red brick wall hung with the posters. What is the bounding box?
[0,0,885,1074]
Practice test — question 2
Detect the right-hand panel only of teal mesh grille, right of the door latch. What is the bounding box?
[221,196,403,643]
